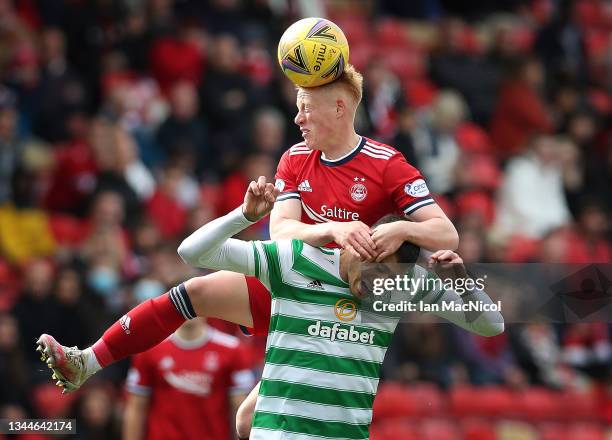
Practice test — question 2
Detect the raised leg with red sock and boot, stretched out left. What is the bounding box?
[37,271,253,391]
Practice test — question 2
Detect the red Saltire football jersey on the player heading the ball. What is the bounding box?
[276,137,435,235]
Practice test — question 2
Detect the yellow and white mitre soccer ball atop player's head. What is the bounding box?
[278,17,349,87]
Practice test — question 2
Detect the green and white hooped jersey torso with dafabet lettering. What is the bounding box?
[250,240,397,440]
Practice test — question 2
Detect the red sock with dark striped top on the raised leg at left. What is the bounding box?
[92,285,195,367]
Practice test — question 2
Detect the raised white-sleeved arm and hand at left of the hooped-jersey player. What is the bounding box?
[178,176,279,275]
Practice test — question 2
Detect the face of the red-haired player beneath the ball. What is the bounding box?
[294,88,337,150]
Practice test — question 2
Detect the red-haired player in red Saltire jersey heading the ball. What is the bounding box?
[39,66,459,437]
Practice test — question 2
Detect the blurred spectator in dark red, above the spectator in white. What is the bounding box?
[491,58,553,158]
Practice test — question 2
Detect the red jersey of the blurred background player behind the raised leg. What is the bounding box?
[126,328,255,440]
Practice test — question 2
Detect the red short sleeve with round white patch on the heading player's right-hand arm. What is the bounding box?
[384,154,435,215]
